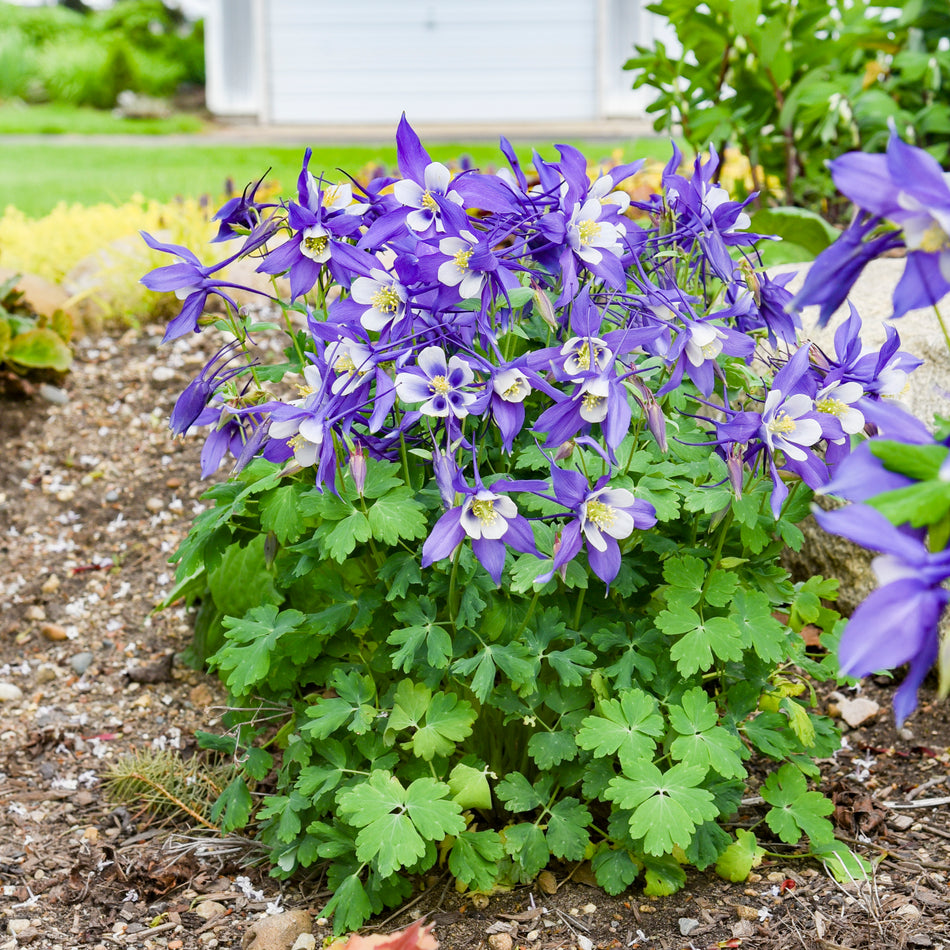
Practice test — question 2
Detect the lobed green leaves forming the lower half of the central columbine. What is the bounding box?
[169,447,837,929]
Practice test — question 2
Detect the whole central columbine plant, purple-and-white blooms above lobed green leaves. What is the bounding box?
[146,120,928,929]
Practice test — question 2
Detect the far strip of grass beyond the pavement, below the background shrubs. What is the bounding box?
[0,102,204,135]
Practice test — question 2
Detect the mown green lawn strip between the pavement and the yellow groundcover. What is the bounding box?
[0,139,670,217]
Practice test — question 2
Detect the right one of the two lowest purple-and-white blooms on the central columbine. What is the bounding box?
[536,467,656,585]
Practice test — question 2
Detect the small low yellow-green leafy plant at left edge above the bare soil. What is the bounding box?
[0,275,73,374]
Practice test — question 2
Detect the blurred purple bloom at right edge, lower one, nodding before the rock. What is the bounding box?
[814,505,950,726]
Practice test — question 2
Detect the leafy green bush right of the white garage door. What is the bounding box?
[625,0,950,214]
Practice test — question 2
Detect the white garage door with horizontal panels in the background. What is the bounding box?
[258,0,602,124]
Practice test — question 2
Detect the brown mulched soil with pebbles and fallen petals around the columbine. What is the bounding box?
[0,328,950,950]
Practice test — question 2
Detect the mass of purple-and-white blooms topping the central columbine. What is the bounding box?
[144,119,915,585]
